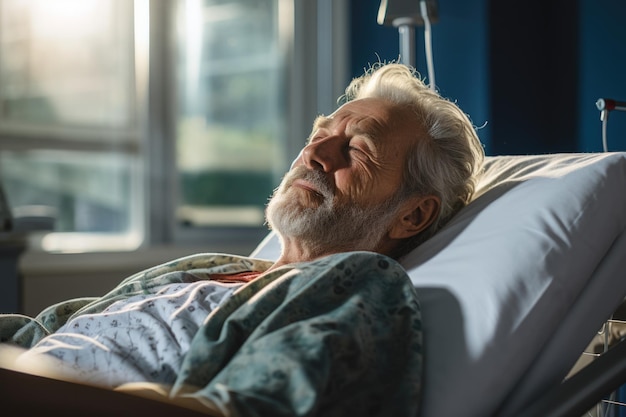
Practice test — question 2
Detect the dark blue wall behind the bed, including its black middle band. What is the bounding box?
[351,0,626,154]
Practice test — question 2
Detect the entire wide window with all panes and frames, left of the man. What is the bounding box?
[0,0,347,252]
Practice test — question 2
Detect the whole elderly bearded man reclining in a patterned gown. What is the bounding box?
[0,64,483,416]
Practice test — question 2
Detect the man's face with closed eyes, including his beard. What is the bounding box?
[267,98,419,250]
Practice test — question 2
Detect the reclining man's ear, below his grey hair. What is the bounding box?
[389,195,441,239]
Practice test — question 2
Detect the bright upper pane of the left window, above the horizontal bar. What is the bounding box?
[0,0,135,129]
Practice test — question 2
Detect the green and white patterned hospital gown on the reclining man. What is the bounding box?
[0,252,422,416]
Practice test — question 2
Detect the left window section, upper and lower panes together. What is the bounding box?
[0,0,141,250]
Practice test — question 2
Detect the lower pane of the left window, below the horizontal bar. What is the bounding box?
[0,151,137,233]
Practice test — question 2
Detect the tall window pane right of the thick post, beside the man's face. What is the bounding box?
[176,0,285,225]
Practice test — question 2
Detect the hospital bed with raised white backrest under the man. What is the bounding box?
[0,153,626,417]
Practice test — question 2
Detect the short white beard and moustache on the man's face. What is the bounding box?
[266,166,399,253]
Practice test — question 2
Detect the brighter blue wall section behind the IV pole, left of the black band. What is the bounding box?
[351,0,490,147]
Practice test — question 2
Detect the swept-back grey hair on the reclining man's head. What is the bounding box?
[340,63,485,258]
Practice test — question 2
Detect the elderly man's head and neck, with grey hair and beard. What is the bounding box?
[267,65,483,265]
